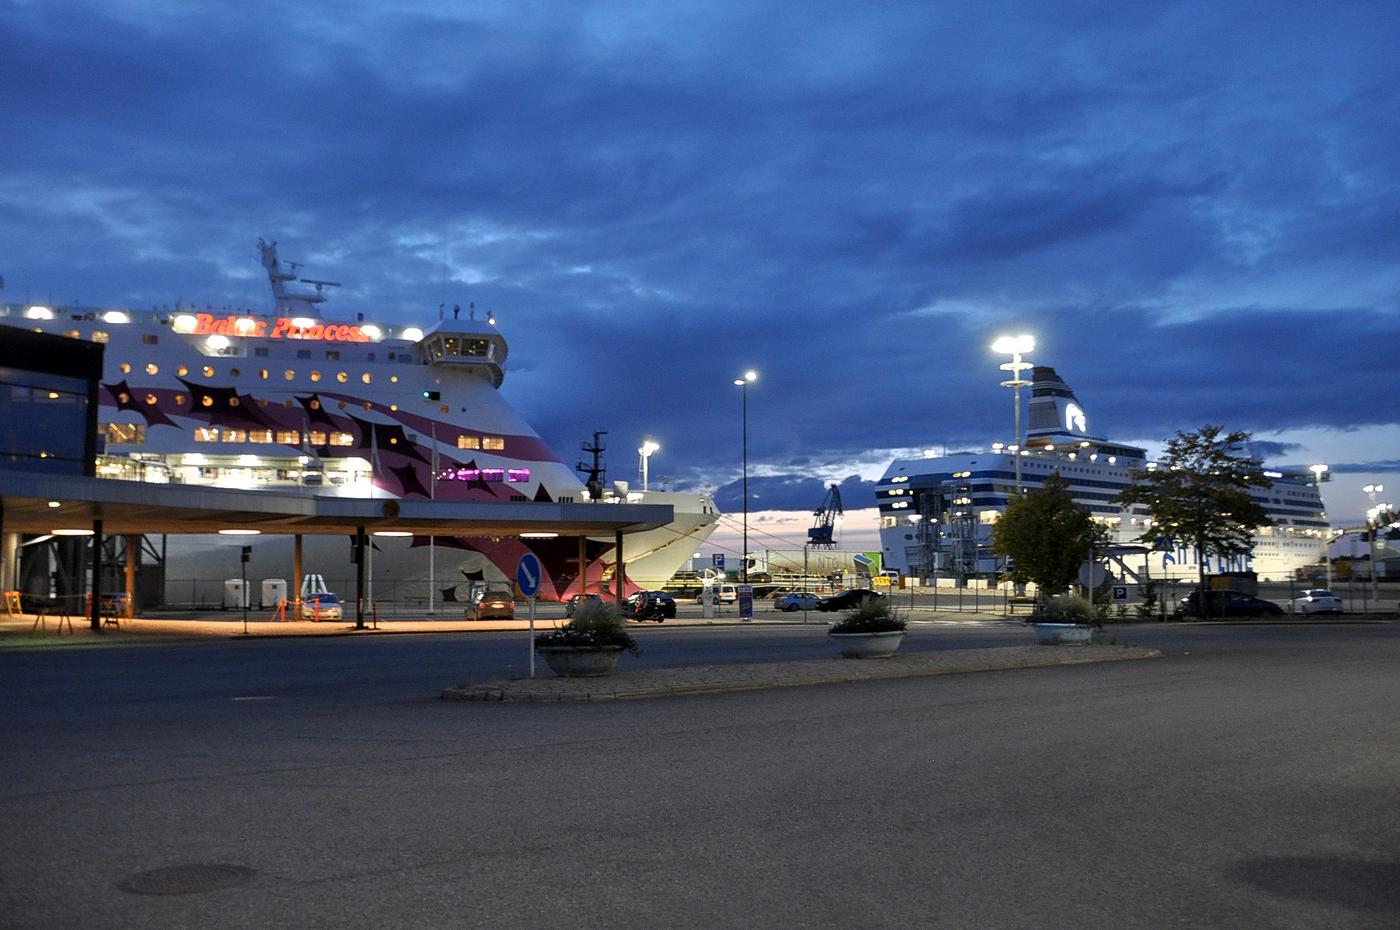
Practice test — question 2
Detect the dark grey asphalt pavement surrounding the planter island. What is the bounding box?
[0,622,1400,929]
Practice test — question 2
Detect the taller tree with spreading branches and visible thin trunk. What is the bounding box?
[1117,424,1273,613]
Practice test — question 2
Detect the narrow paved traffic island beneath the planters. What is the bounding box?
[442,646,1162,702]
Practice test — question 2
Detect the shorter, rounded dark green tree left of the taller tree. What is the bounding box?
[991,475,1107,597]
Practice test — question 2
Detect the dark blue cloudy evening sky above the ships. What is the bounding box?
[0,0,1400,545]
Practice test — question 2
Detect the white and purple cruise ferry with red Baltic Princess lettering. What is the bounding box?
[0,240,720,604]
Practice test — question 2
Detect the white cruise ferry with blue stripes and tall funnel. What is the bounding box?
[875,366,1327,581]
